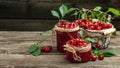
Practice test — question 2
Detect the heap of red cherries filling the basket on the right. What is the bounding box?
[76,19,112,30]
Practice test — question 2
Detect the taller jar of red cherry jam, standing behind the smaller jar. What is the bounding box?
[54,22,79,53]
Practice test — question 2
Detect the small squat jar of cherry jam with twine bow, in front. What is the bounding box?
[64,38,92,63]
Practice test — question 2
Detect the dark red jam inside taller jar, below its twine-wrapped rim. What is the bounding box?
[56,30,78,53]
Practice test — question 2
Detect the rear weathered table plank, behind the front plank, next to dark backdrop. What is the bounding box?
[0,31,120,54]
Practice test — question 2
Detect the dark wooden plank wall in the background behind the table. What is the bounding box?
[0,0,120,31]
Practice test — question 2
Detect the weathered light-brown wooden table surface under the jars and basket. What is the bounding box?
[0,31,120,68]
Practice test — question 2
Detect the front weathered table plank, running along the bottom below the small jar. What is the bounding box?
[0,54,120,68]
